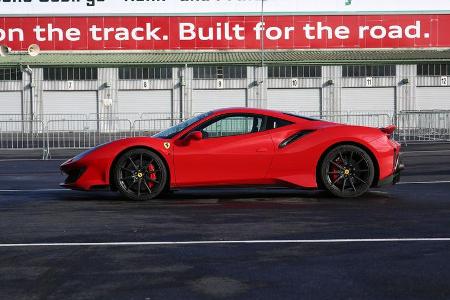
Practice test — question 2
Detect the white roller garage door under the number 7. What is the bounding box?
[42,91,98,115]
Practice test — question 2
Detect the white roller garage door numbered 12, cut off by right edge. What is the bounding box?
[416,87,450,110]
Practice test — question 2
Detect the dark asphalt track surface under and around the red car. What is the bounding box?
[0,145,450,300]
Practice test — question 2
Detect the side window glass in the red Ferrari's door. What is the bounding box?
[201,115,263,138]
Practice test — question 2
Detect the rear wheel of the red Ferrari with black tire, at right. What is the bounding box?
[320,145,375,198]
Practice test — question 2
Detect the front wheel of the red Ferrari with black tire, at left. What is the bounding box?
[113,149,168,201]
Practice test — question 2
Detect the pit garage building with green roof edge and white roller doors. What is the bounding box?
[0,50,450,118]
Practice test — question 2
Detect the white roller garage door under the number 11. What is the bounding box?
[341,88,395,114]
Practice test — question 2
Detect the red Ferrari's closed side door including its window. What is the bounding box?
[173,114,274,186]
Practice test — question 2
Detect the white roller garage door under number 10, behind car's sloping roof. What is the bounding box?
[267,89,320,113]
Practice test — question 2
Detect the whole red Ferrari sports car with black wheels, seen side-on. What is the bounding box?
[61,108,403,200]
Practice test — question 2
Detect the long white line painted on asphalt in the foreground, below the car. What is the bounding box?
[0,238,450,248]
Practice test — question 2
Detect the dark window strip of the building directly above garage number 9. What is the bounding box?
[194,66,247,79]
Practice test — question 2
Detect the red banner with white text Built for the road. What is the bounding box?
[0,15,450,50]
